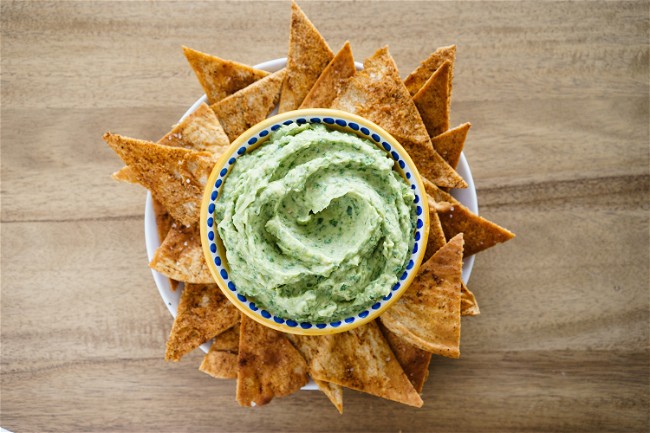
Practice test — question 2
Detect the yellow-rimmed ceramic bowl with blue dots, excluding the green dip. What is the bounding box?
[200,108,429,335]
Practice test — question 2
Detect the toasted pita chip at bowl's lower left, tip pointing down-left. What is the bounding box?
[165,284,239,361]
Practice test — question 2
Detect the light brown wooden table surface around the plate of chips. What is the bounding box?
[0,1,650,433]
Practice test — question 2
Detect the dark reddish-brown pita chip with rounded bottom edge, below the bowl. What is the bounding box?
[237,315,308,406]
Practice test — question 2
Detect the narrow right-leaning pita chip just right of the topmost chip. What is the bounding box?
[300,42,357,108]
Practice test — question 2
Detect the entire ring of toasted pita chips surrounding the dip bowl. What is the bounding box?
[104,3,514,412]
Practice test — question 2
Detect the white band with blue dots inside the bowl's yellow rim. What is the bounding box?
[206,117,424,330]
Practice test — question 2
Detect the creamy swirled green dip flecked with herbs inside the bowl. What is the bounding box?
[215,124,416,323]
